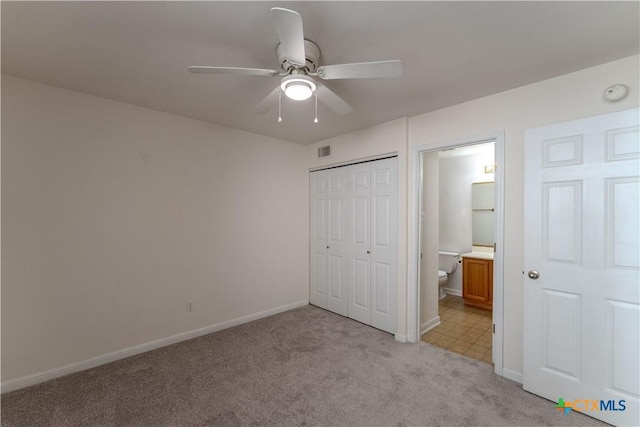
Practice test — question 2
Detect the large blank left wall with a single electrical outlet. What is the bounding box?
[2,76,309,382]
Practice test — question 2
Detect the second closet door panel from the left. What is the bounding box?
[326,167,348,316]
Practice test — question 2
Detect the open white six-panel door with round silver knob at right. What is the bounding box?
[524,110,640,426]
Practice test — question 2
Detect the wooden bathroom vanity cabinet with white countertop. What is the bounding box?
[462,252,493,310]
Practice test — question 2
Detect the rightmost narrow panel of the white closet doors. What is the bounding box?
[370,158,398,333]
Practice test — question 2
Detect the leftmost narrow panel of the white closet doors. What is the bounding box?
[309,171,329,308]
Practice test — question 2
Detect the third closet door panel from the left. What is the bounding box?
[347,163,371,324]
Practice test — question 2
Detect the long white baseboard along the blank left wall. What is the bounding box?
[0,300,309,393]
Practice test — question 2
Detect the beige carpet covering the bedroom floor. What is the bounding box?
[1,306,602,426]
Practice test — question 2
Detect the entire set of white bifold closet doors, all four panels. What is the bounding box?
[310,158,398,333]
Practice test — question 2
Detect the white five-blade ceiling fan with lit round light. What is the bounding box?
[188,7,402,121]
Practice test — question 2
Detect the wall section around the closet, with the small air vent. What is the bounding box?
[307,118,408,340]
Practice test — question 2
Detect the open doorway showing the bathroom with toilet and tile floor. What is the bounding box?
[416,136,502,372]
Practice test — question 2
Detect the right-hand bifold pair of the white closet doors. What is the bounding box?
[347,157,398,333]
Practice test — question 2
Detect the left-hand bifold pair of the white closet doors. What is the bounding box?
[309,167,347,316]
